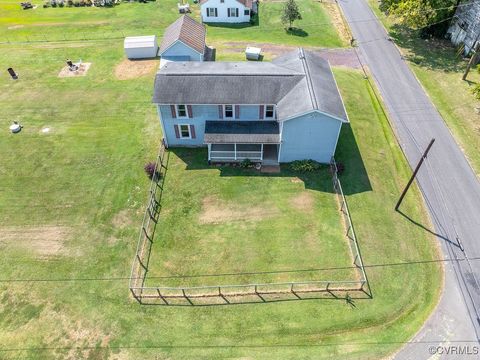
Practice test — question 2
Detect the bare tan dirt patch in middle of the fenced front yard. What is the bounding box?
[199,196,279,224]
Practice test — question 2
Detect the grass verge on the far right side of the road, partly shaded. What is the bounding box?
[370,0,480,175]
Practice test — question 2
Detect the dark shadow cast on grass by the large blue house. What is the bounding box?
[169,125,372,195]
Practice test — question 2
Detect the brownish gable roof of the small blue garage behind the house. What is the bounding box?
[160,15,206,55]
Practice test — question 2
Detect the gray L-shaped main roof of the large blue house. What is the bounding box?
[153,49,348,121]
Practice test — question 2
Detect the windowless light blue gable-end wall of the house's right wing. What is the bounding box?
[280,112,342,163]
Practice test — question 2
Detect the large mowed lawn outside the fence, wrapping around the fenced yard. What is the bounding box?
[0,32,441,359]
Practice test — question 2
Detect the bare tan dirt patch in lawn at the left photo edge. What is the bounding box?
[0,226,72,257]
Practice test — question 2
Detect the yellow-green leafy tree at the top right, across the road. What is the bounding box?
[380,0,460,29]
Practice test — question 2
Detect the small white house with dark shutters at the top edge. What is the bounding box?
[200,0,258,23]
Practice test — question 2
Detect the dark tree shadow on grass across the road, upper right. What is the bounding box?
[390,24,466,72]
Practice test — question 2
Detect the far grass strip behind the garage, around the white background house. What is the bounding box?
[0,0,346,49]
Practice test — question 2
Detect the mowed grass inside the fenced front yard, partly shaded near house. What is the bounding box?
[147,149,358,286]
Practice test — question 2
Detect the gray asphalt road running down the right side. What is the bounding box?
[339,0,480,360]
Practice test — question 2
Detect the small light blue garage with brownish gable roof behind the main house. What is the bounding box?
[159,15,207,61]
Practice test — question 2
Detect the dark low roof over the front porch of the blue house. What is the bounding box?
[204,120,280,144]
